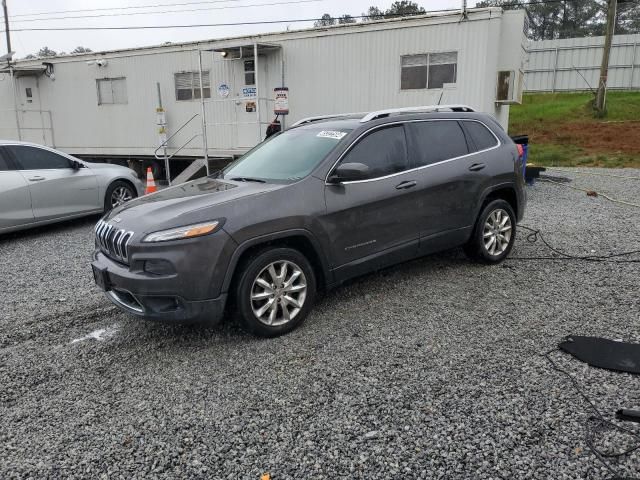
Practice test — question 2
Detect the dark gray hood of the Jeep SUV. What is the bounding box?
[104,177,284,232]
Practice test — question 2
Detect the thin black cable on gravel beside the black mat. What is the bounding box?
[544,348,640,480]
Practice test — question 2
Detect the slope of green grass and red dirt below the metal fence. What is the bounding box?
[509,92,640,168]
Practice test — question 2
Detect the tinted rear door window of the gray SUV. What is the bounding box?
[407,120,469,167]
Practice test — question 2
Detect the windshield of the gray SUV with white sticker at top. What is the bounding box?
[222,128,351,183]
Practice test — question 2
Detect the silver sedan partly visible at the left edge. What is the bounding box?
[0,140,144,234]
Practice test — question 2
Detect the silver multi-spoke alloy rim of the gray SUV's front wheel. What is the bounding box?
[250,260,307,327]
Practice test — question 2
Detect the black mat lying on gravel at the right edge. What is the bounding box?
[558,336,640,374]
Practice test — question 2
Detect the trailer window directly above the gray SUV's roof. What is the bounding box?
[400,52,458,90]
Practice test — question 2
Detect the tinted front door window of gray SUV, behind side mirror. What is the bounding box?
[341,125,409,179]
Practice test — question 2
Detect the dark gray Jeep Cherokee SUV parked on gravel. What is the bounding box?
[92,106,526,337]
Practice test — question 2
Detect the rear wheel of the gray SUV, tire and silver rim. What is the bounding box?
[463,200,516,264]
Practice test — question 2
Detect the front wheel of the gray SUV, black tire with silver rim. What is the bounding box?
[234,248,316,338]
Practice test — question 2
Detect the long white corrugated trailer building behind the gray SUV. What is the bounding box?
[0,8,526,180]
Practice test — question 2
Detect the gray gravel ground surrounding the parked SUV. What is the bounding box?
[0,169,640,480]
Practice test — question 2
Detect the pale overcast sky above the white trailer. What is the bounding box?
[0,0,475,58]
